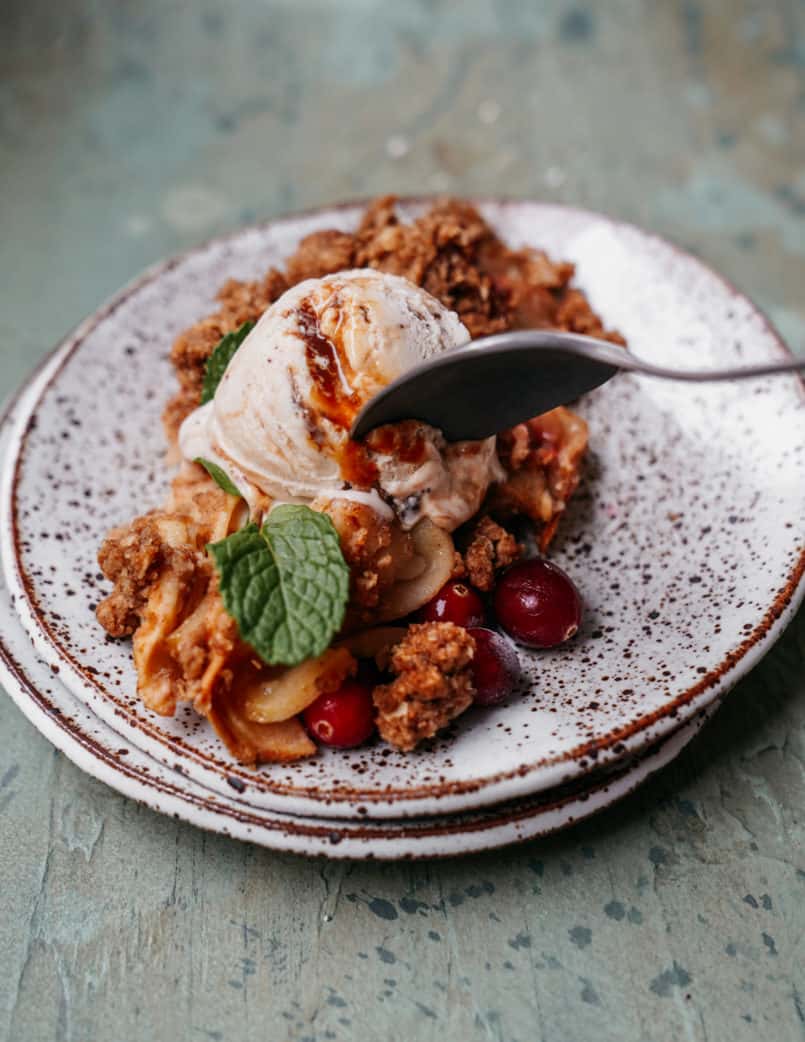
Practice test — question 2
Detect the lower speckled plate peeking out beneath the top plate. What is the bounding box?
[0,582,713,861]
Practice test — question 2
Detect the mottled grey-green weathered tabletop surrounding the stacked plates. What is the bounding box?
[0,0,805,1042]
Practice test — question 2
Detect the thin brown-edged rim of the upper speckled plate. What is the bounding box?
[2,196,805,816]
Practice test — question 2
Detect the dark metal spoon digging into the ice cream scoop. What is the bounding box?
[352,329,805,442]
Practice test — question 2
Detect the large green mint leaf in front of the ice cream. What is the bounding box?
[207,503,350,666]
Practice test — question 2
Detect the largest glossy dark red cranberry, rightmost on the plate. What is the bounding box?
[495,557,581,648]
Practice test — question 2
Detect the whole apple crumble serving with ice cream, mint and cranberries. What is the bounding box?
[97,198,623,764]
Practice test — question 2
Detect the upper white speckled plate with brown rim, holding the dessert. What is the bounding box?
[0,202,805,818]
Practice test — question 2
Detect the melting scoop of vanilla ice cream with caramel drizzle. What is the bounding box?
[179,269,498,529]
